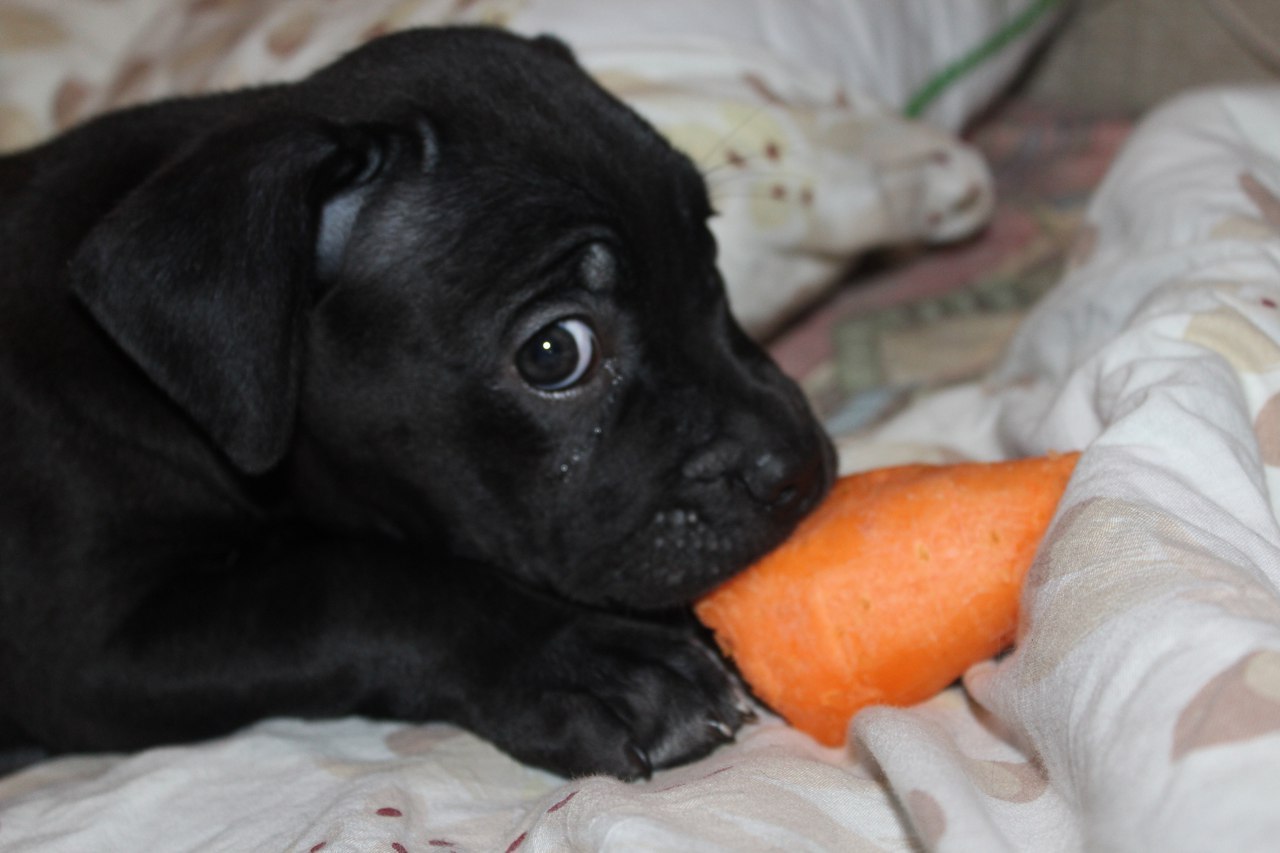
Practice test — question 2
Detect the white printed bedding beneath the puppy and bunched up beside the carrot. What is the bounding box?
[0,84,1280,853]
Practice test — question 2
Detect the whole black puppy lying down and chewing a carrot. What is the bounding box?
[0,29,832,777]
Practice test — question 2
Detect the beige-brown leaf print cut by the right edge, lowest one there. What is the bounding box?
[1172,649,1280,761]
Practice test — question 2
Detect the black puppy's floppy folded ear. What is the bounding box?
[70,118,396,474]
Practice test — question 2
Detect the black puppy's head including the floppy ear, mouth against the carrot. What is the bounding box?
[77,31,832,607]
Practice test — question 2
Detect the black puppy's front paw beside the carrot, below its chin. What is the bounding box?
[490,613,754,779]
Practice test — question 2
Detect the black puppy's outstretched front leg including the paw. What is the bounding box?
[40,535,749,777]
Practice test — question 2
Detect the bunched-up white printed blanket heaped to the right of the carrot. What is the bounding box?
[834,88,1280,850]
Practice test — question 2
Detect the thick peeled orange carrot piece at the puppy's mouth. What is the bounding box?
[696,453,1079,745]
